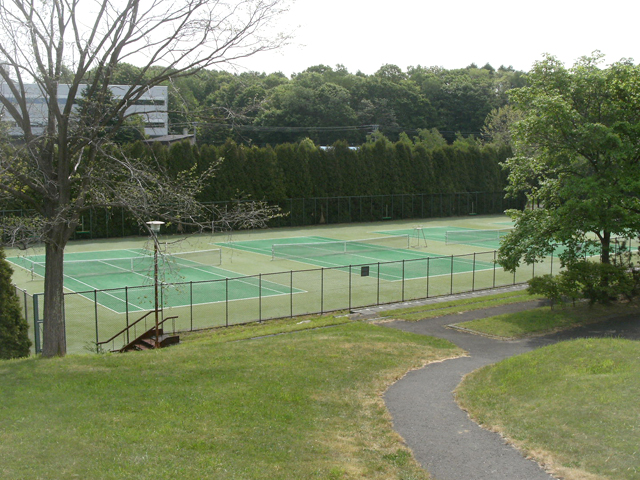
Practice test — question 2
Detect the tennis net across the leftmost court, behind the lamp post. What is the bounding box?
[25,248,222,278]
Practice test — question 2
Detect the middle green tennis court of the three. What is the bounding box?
[217,233,494,281]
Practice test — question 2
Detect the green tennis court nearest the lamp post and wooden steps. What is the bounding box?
[8,249,303,313]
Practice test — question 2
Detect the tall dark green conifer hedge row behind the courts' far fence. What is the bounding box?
[131,131,511,202]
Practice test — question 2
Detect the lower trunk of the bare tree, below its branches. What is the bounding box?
[42,236,67,357]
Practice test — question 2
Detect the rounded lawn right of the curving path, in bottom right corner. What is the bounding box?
[457,339,640,480]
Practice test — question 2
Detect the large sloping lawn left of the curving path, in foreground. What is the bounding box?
[0,319,461,480]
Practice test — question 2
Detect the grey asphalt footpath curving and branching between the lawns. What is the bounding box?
[356,292,640,480]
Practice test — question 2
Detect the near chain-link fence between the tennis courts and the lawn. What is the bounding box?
[20,251,558,353]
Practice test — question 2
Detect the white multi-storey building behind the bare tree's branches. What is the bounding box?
[0,83,169,137]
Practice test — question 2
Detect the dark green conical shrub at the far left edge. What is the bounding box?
[0,249,31,360]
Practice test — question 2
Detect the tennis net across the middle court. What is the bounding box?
[271,235,409,260]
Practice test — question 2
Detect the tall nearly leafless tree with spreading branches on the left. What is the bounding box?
[0,0,287,356]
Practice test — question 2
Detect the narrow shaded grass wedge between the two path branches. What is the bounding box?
[456,303,638,338]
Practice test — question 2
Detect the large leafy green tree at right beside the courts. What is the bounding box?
[499,52,640,287]
